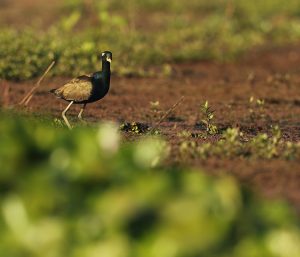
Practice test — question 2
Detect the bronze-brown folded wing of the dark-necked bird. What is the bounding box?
[54,75,92,102]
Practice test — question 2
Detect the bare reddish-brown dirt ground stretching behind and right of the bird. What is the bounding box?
[1,45,300,212]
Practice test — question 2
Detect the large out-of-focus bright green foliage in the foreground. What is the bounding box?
[0,114,300,257]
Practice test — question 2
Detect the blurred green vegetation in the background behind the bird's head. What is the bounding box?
[0,0,300,80]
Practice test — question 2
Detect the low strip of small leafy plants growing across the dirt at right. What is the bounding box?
[180,126,300,160]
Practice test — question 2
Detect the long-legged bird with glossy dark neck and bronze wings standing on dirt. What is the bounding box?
[50,51,112,129]
